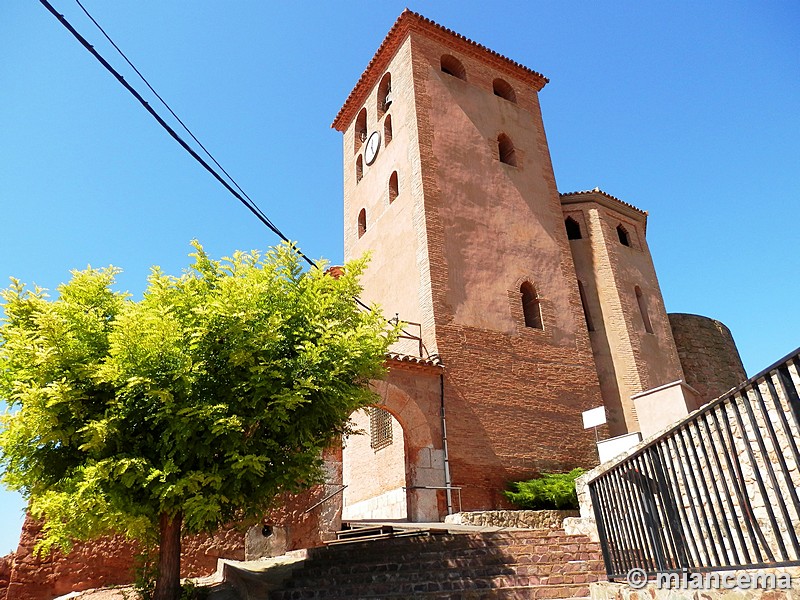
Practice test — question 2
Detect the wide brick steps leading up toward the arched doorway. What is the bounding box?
[260,530,605,600]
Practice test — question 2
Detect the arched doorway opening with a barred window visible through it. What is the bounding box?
[342,406,408,521]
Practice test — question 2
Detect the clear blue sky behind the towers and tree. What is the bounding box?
[0,0,800,554]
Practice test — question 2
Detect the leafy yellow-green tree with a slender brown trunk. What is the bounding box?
[0,242,397,600]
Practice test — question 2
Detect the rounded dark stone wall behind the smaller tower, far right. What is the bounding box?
[669,313,747,402]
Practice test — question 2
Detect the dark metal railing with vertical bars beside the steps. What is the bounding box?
[588,349,800,580]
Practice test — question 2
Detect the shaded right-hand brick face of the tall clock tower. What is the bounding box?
[406,35,602,510]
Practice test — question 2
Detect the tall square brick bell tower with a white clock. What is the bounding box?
[333,10,602,510]
